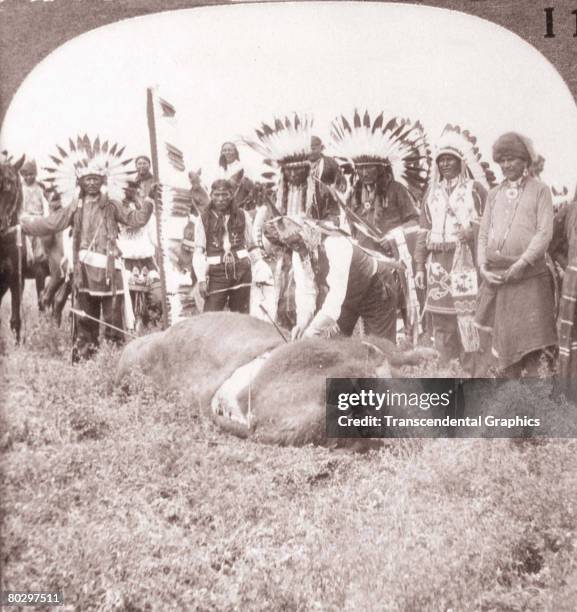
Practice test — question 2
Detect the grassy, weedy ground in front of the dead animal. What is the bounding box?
[0,287,577,612]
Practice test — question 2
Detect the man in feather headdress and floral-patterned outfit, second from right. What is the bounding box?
[415,125,494,374]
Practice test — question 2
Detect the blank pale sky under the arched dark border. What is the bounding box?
[1,2,577,194]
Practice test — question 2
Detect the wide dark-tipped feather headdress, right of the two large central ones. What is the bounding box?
[331,110,431,201]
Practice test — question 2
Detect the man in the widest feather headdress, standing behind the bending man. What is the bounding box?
[331,111,430,342]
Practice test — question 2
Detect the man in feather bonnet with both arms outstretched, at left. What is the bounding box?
[22,137,154,361]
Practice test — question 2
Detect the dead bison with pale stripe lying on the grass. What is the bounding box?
[118,312,430,445]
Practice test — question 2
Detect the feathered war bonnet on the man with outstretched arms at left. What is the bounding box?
[44,135,134,205]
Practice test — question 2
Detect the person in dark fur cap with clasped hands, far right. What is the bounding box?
[475,132,557,377]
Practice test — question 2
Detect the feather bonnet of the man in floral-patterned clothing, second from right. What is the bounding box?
[434,124,495,189]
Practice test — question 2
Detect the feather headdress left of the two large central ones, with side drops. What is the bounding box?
[242,113,315,214]
